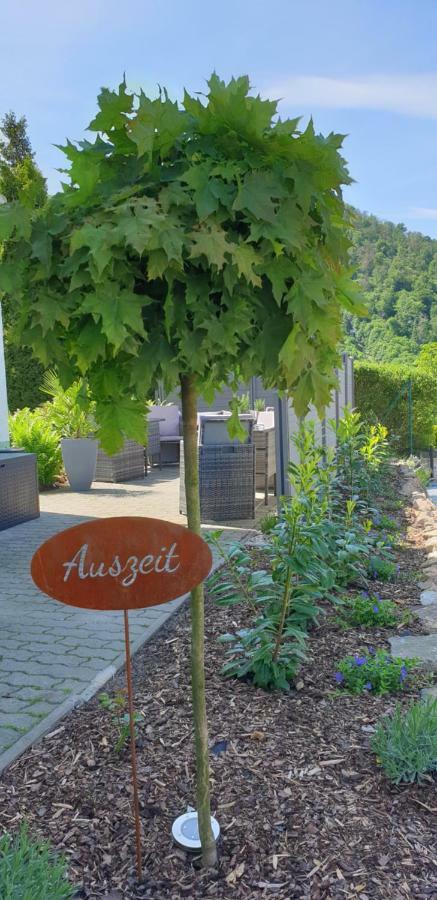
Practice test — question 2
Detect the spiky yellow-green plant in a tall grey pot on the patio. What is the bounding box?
[42,372,98,491]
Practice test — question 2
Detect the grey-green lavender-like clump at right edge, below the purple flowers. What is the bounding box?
[372,698,437,784]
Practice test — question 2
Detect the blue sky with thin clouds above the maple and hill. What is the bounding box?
[0,0,437,237]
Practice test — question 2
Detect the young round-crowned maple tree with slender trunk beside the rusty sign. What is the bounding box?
[0,74,359,865]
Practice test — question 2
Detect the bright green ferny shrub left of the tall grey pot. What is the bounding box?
[9,408,62,488]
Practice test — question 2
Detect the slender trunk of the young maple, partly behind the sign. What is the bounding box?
[181,375,217,866]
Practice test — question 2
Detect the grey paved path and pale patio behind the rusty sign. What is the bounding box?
[0,468,255,771]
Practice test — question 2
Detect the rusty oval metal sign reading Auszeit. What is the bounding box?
[31,516,212,610]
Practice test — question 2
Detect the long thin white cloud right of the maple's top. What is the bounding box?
[266,72,437,119]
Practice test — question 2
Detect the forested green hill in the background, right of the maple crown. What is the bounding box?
[345,211,437,363]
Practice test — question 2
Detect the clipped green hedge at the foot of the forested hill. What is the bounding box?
[355,361,437,452]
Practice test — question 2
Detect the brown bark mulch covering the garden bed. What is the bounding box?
[0,492,437,900]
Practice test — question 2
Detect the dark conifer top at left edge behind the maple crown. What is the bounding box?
[0,112,47,206]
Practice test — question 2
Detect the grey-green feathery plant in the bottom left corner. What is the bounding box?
[0,825,76,900]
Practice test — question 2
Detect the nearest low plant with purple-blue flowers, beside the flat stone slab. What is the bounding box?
[334,649,417,694]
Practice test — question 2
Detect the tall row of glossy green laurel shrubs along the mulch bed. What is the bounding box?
[208,411,391,690]
